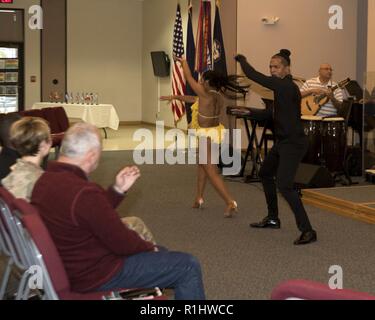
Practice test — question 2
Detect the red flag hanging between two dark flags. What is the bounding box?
[195,0,212,73]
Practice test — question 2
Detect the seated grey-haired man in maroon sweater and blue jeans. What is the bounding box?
[31,123,205,300]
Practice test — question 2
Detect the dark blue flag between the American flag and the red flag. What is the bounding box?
[185,0,198,123]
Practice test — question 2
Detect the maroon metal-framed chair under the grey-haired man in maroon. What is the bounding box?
[14,199,166,300]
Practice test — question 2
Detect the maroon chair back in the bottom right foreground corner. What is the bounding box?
[271,280,375,300]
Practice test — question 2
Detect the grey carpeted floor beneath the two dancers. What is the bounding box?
[0,151,375,300]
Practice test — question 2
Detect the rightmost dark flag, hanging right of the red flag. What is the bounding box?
[213,0,228,76]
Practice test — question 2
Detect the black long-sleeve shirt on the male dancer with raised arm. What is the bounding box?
[236,55,304,140]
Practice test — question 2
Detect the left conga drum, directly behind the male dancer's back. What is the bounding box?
[301,116,323,165]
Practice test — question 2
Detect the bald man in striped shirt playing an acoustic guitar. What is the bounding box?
[300,63,344,117]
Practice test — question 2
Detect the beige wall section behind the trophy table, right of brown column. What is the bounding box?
[67,0,143,121]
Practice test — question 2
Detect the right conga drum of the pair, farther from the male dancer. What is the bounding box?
[322,118,347,172]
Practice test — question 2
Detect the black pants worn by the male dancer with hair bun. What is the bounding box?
[259,137,312,232]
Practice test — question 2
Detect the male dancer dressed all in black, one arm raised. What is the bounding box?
[235,49,317,245]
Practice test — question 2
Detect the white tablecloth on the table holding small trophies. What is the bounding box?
[32,102,120,130]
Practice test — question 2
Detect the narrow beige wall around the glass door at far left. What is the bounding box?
[0,0,41,109]
